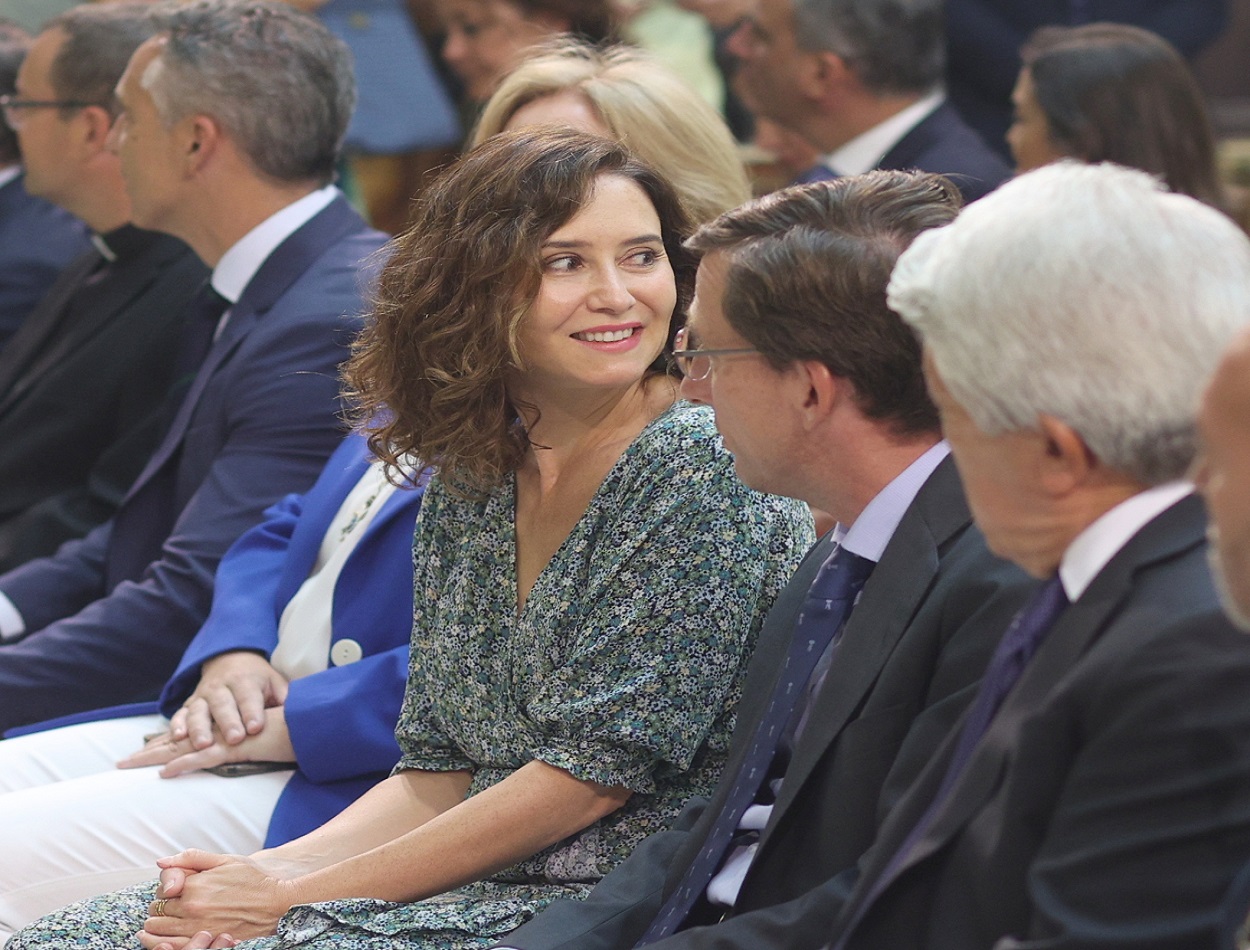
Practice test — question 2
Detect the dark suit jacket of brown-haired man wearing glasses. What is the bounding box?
[504,459,1033,950]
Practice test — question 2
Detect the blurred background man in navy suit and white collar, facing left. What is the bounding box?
[729,0,1011,201]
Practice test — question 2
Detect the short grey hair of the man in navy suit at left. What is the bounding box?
[141,0,356,183]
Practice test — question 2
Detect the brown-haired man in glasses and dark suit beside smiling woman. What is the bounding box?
[492,171,1031,950]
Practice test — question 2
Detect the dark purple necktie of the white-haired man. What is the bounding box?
[834,574,1068,950]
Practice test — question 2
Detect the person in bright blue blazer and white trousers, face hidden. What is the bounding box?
[0,434,423,940]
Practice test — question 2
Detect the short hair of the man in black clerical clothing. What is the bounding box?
[44,3,164,115]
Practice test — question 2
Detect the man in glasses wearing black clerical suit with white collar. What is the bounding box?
[0,4,208,570]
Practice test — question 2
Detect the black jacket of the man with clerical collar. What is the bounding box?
[0,228,209,571]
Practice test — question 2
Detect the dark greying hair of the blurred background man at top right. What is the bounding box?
[794,0,946,95]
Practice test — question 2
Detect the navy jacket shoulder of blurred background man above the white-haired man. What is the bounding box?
[876,103,1011,201]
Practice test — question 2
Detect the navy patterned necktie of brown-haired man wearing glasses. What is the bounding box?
[638,548,875,946]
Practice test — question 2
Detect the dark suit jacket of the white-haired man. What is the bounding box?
[830,498,1250,950]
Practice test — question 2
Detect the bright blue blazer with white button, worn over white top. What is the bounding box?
[160,434,424,848]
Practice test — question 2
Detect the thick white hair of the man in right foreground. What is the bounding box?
[889,161,1250,485]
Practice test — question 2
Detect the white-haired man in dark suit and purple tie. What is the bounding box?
[815,164,1250,950]
